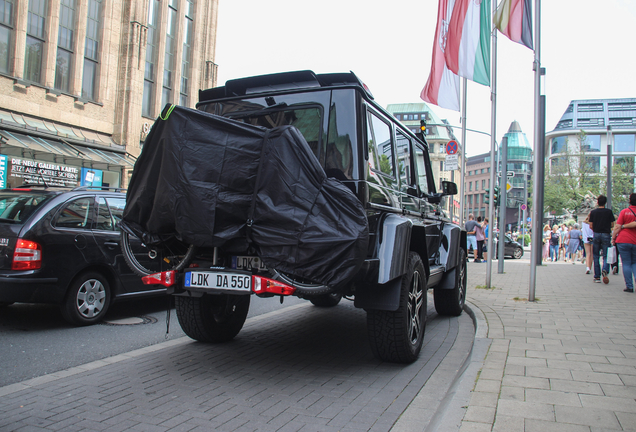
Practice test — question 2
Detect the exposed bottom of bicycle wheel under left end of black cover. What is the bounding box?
[121,230,196,277]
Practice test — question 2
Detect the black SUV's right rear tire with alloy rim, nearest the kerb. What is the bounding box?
[367,252,427,363]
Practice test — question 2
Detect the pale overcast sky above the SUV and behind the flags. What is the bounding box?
[216,0,636,156]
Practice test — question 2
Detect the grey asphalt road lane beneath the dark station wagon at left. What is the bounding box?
[0,296,306,387]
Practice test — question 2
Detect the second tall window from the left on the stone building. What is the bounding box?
[24,0,47,83]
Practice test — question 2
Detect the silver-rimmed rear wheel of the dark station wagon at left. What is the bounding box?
[60,272,111,326]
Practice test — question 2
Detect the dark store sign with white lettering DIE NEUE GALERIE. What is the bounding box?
[9,158,80,186]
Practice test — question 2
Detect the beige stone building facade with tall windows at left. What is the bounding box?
[0,0,218,188]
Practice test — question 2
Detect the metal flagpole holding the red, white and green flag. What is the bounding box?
[486,1,497,288]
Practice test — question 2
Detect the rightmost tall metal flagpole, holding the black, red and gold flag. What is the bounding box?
[528,0,545,301]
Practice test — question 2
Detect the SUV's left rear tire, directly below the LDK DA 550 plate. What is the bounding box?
[175,294,250,342]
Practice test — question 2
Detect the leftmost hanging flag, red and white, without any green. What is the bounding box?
[420,0,459,111]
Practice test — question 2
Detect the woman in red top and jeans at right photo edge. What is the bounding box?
[612,193,636,292]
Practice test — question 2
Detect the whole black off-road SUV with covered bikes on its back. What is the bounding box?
[122,71,466,363]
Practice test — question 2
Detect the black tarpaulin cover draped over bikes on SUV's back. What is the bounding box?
[121,107,368,285]
